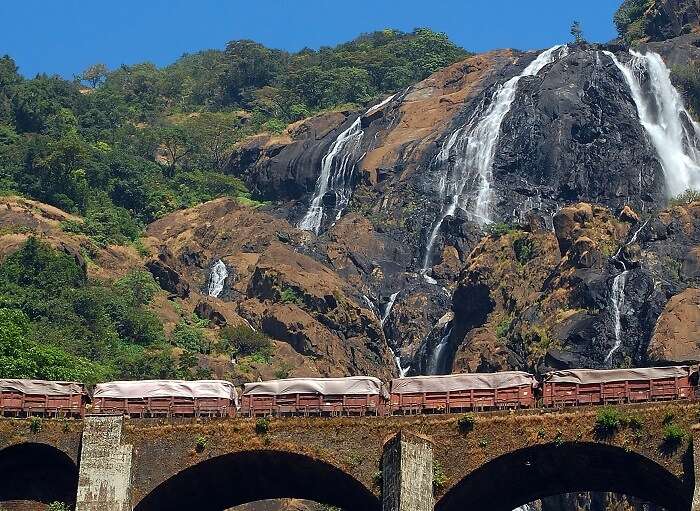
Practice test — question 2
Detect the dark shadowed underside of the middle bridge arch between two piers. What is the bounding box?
[134,450,380,511]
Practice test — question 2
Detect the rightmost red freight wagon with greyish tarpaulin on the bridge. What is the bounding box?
[542,366,695,407]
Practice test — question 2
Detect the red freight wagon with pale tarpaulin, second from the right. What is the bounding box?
[391,371,537,414]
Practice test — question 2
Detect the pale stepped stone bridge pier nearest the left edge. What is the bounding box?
[75,416,133,511]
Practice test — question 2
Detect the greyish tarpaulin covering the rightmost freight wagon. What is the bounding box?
[544,366,690,384]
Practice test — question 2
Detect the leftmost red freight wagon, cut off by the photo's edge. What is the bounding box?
[0,379,87,417]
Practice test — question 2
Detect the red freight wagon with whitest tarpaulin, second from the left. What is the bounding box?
[92,380,238,417]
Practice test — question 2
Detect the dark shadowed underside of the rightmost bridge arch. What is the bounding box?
[435,442,693,511]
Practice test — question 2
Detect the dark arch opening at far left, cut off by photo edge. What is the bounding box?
[0,442,78,505]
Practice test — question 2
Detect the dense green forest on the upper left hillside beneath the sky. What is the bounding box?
[0,29,467,238]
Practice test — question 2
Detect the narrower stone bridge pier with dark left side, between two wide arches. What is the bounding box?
[382,432,435,511]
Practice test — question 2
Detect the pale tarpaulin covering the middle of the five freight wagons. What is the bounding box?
[243,376,386,396]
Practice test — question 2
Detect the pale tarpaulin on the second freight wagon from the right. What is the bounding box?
[391,371,537,394]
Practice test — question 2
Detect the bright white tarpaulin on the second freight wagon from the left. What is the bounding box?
[93,380,238,406]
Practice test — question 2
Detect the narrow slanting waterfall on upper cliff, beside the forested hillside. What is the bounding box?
[297,96,394,234]
